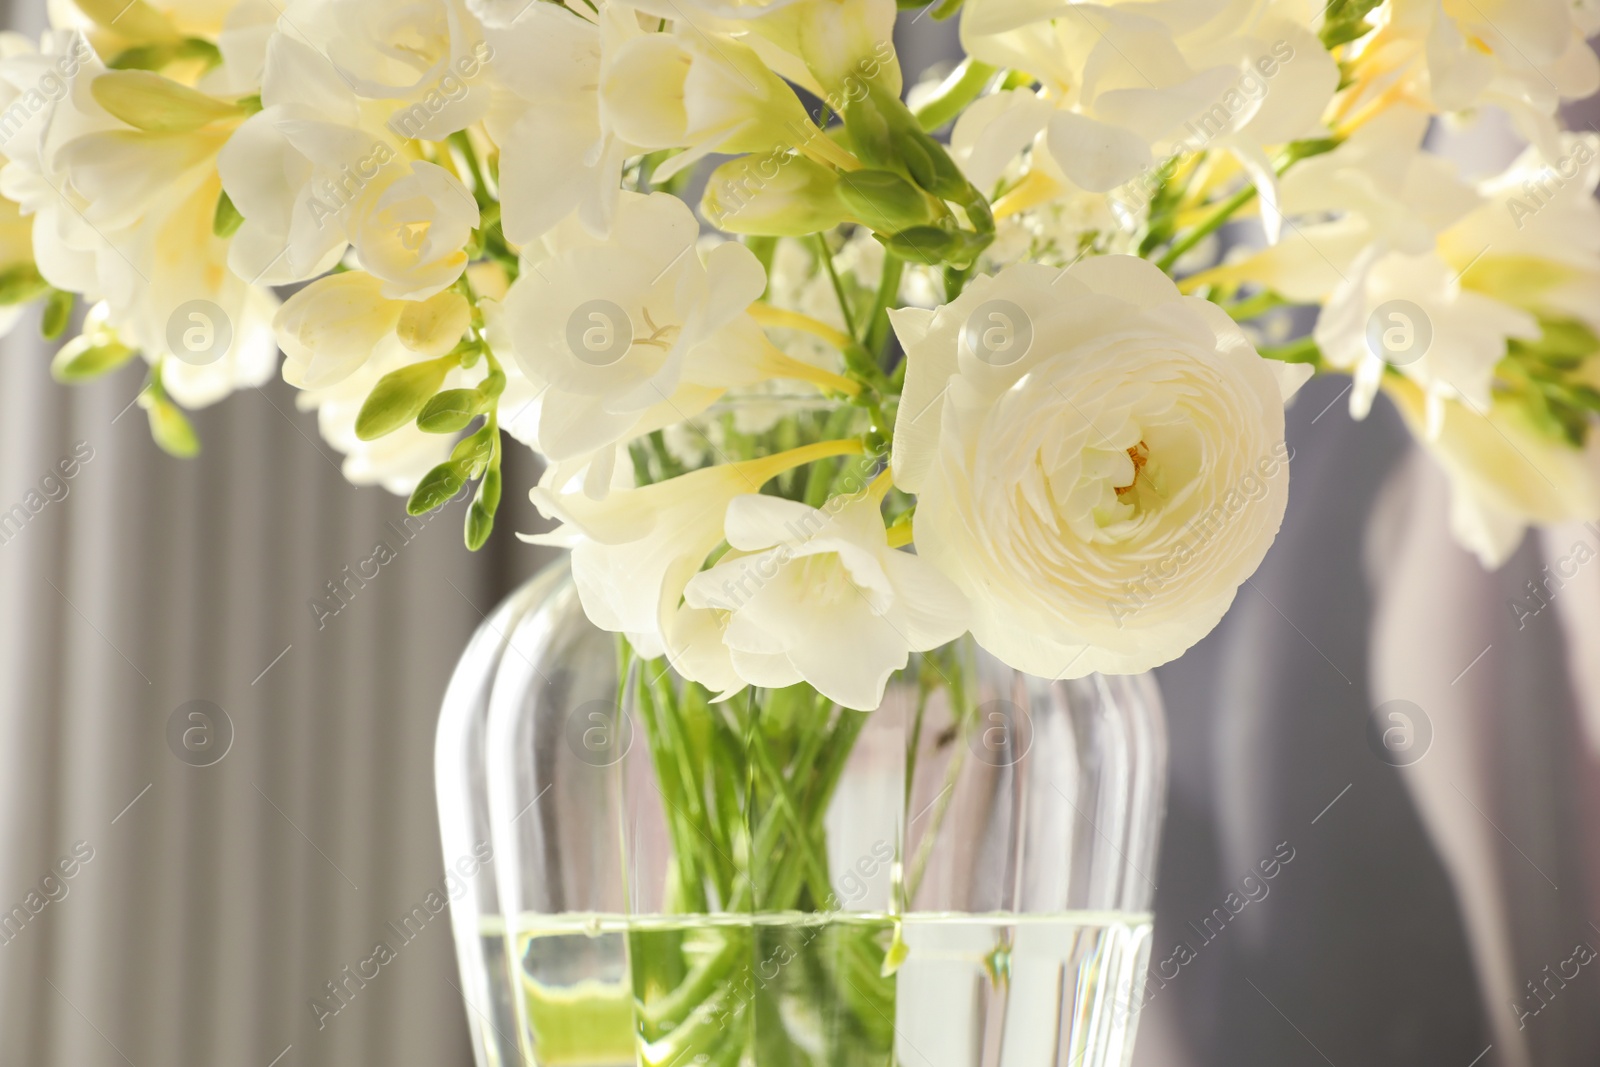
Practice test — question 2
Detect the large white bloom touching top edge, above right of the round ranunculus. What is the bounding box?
[954,0,1339,233]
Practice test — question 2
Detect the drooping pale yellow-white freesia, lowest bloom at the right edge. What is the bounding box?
[1384,378,1600,569]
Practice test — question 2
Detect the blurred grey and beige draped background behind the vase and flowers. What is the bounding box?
[0,0,1600,1067]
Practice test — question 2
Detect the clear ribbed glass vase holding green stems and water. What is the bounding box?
[438,558,1166,1067]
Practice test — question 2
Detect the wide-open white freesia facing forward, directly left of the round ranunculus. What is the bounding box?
[504,192,837,494]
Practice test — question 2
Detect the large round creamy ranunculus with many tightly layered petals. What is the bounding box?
[893,256,1310,678]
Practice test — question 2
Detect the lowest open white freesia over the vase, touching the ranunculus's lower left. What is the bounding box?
[682,493,968,712]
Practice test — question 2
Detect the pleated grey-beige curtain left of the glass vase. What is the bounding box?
[0,0,536,1067]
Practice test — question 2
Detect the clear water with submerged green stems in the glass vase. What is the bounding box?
[499,912,1150,1067]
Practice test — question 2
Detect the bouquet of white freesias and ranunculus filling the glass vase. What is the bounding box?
[9,0,1600,1062]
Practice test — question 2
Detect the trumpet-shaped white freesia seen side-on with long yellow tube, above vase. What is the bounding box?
[523,442,861,659]
